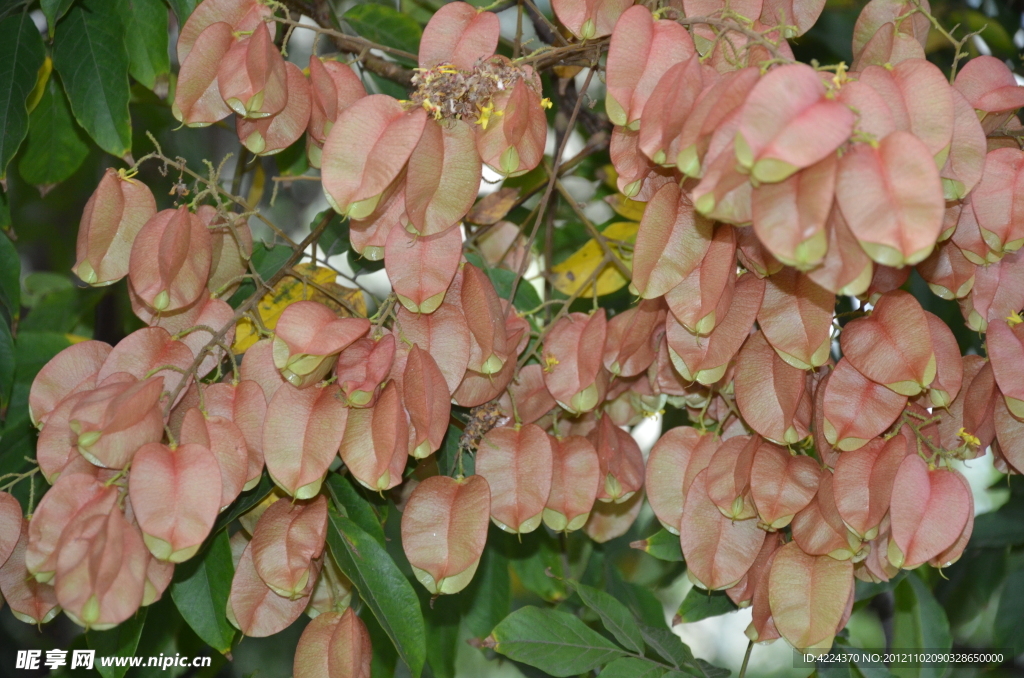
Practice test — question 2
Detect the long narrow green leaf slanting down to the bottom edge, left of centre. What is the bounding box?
[327,504,426,678]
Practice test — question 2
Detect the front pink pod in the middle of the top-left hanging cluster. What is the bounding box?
[217,23,289,119]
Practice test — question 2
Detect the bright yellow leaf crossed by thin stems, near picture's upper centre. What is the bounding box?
[551,221,640,297]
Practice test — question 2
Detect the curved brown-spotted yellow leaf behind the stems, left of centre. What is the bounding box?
[231,263,367,353]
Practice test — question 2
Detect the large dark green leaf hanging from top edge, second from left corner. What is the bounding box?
[53,0,131,158]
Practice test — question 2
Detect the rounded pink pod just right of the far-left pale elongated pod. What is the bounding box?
[128,205,213,311]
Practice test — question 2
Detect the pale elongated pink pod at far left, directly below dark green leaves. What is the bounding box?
[72,168,157,286]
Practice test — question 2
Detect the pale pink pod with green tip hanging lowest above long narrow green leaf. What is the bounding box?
[401,475,490,595]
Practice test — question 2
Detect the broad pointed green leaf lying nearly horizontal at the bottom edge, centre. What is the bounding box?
[490,605,625,677]
